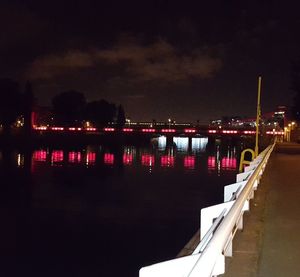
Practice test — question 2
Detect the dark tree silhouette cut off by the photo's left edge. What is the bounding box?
[0,79,21,135]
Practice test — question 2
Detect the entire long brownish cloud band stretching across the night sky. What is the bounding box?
[27,40,222,82]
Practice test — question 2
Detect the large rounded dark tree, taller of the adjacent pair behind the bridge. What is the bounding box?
[52,90,86,126]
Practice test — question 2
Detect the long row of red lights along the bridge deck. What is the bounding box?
[34,126,284,136]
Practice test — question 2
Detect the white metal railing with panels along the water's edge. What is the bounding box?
[139,144,275,277]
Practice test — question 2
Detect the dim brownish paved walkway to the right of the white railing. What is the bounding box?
[222,143,300,277]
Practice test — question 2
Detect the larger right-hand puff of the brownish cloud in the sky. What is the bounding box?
[98,40,222,82]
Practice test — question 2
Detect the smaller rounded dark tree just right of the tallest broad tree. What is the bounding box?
[85,100,116,127]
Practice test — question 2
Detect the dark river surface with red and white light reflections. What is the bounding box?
[0,138,239,277]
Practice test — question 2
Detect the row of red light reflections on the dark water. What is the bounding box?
[29,142,237,173]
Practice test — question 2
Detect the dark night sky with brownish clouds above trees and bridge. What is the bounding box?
[0,0,300,122]
